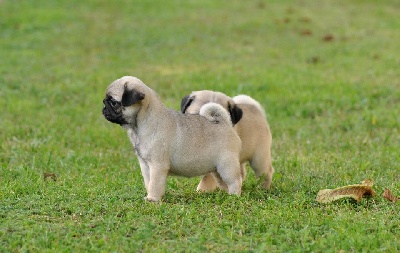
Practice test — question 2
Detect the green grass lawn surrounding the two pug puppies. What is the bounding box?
[0,0,400,252]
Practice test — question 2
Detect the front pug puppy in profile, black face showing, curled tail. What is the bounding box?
[103,76,242,201]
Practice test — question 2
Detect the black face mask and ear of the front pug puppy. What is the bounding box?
[103,85,144,125]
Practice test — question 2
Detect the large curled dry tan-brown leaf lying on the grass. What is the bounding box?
[316,179,375,203]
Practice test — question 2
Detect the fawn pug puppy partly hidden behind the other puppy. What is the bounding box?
[181,90,274,192]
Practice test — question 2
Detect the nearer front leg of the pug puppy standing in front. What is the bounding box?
[145,164,168,202]
